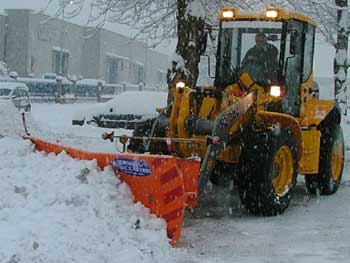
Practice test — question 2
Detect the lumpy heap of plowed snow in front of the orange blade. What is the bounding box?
[0,137,171,263]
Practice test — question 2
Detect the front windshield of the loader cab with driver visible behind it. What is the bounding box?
[216,21,282,87]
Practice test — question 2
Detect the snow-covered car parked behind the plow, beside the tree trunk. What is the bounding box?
[72,91,167,129]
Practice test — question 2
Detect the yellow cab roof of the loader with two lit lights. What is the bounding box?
[219,7,316,26]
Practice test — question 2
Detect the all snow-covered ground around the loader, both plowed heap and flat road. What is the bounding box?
[0,101,350,263]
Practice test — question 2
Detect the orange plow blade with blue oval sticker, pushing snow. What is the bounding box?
[24,136,200,245]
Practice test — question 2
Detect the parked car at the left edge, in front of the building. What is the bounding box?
[0,82,31,111]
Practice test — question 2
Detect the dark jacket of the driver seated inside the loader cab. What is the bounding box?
[242,43,278,83]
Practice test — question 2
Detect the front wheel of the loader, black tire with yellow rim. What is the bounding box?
[238,128,298,216]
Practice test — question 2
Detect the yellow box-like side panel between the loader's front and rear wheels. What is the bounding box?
[299,128,321,174]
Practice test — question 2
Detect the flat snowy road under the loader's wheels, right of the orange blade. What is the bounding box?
[180,170,350,263]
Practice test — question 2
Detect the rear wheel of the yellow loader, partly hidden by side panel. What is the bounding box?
[305,124,344,195]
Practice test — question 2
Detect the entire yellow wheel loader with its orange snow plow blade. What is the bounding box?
[25,8,344,243]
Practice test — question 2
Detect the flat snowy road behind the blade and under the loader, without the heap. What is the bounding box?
[0,104,350,263]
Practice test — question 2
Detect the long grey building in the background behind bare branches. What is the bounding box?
[0,9,168,85]
